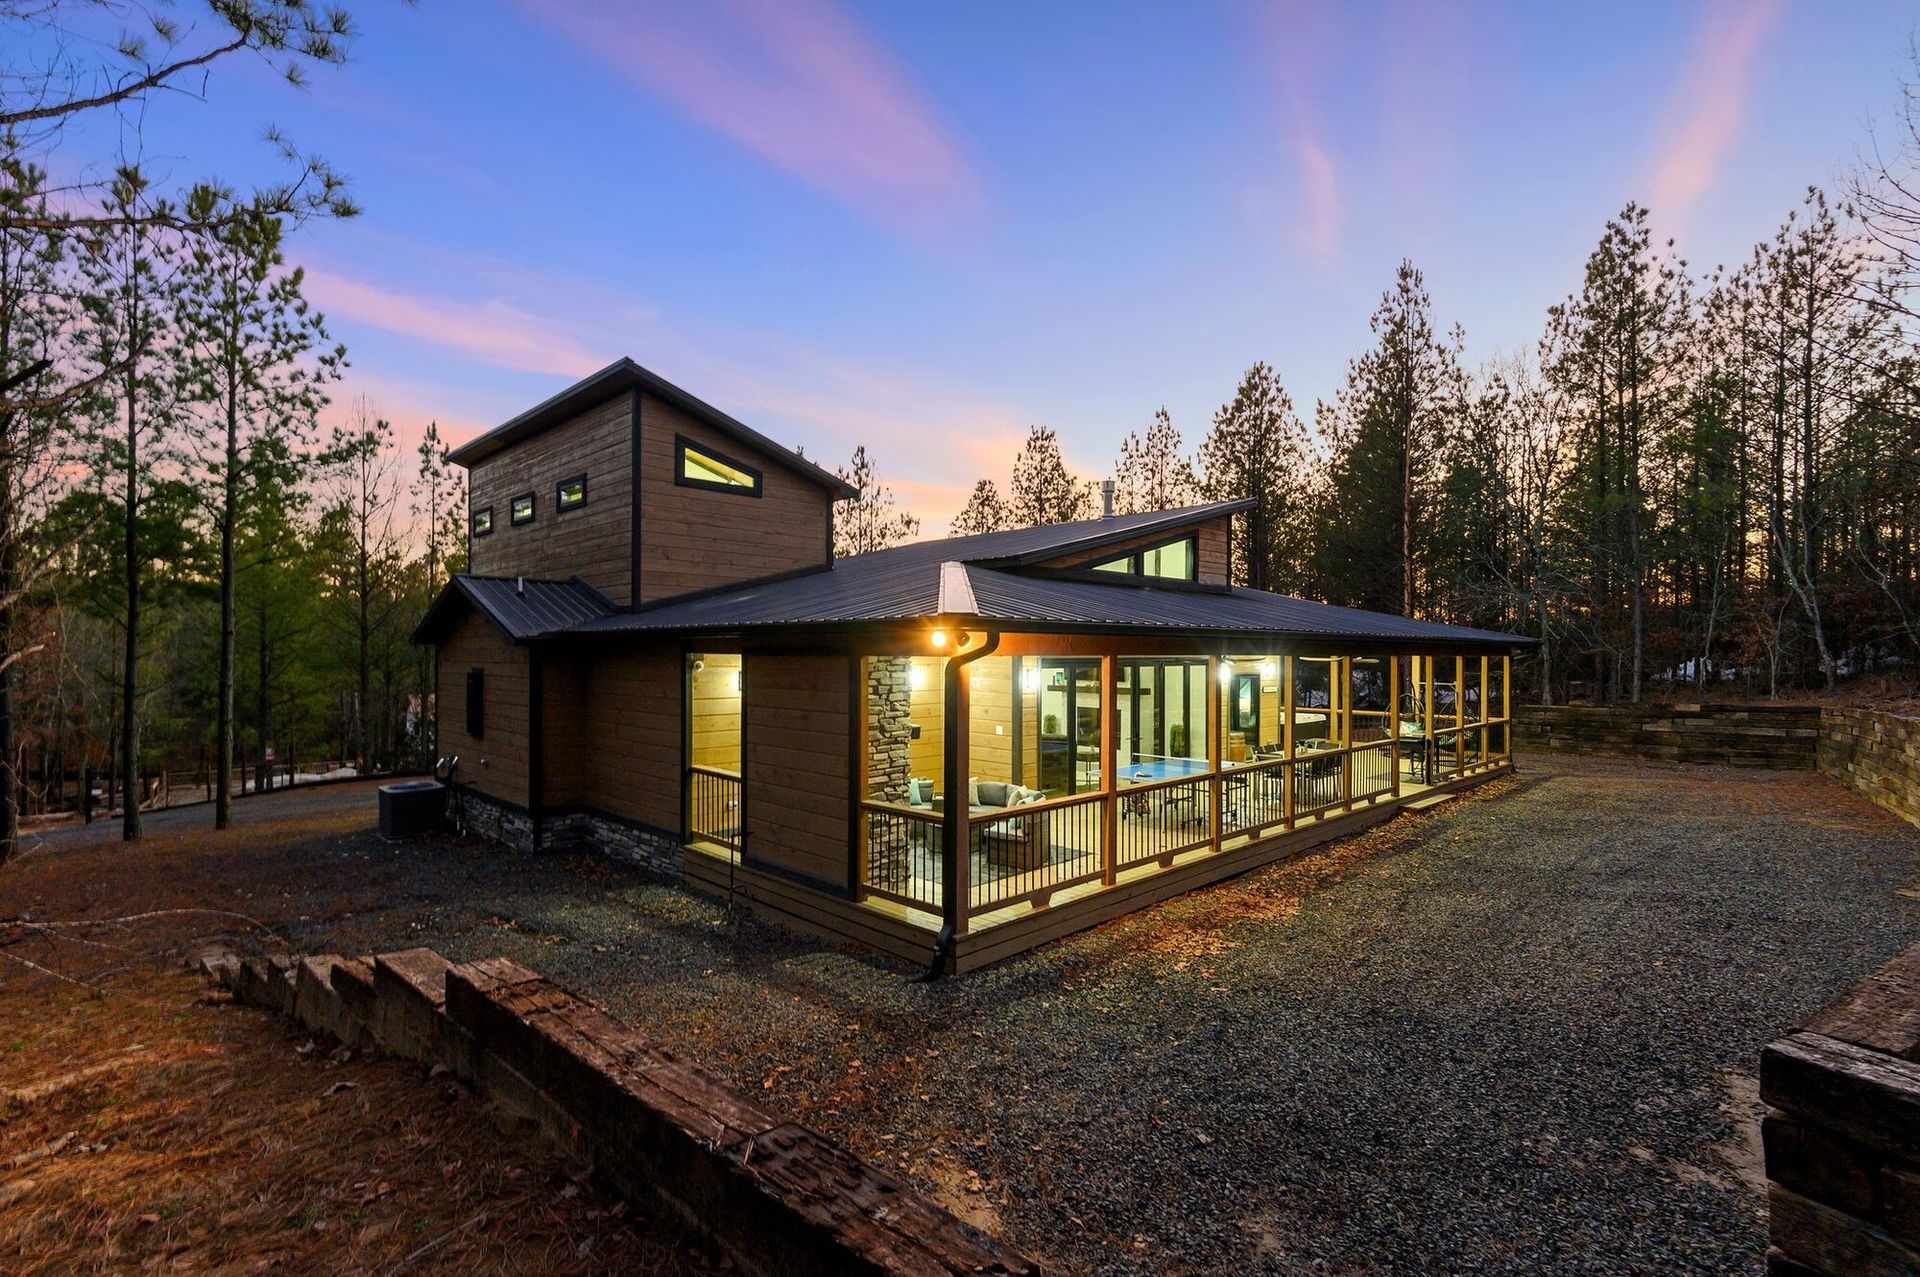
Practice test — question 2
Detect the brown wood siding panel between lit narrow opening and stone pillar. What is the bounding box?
[745,653,852,883]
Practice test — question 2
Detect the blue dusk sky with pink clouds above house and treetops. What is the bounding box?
[22,0,1916,532]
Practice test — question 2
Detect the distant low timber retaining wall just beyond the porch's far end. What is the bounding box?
[1513,705,1820,768]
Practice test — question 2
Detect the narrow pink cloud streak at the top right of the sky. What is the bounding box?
[1649,0,1780,223]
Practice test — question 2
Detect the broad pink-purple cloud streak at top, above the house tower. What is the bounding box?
[522,0,979,227]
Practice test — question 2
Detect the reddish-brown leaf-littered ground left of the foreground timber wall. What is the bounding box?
[0,785,712,1273]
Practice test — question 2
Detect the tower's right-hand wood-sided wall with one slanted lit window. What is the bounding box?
[639,396,833,603]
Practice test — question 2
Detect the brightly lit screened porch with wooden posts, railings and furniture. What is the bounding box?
[854,636,1511,933]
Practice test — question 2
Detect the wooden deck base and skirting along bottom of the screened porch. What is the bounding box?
[685,762,1513,972]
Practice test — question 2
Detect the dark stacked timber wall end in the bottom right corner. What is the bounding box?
[1761,947,1920,1277]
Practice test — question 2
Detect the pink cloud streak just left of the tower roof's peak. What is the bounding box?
[307,269,612,376]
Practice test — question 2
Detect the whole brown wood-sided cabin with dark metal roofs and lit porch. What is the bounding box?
[415,359,1526,972]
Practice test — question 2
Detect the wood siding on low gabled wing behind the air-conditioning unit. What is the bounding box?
[436,613,528,807]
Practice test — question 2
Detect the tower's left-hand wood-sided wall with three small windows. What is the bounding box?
[467,394,634,603]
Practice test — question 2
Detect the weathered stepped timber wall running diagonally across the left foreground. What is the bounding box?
[202,949,1039,1277]
